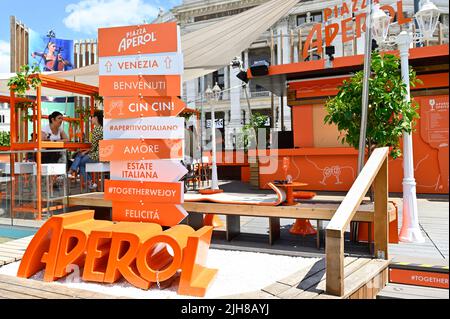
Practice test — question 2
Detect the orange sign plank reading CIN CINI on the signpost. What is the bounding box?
[103,96,186,119]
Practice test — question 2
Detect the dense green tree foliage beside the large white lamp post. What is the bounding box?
[324,52,420,158]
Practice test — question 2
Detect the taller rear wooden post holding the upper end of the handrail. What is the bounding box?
[373,157,389,259]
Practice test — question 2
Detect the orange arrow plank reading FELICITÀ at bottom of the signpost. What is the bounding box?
[112,201,188,226]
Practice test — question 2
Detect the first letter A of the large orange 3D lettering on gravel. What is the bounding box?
[17,211,94,281]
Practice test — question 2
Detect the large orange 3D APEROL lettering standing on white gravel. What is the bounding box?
[17,211,217,297]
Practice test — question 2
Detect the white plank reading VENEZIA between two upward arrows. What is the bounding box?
[99,52,183,75]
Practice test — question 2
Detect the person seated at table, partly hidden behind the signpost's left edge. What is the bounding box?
[68,110,103,189]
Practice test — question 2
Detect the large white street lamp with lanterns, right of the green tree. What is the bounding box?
[372,0,440,243]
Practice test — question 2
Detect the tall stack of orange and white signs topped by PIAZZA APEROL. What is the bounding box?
[99,23,187,226]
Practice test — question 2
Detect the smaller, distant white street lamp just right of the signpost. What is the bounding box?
[205,82,223,193]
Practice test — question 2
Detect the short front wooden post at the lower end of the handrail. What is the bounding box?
[325,230,344,296]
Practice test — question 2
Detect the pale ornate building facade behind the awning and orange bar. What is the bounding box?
[154,0,449,150]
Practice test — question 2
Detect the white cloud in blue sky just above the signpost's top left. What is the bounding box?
[63,0,158,34]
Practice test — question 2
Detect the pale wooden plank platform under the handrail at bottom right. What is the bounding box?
[224,257,389,299]
